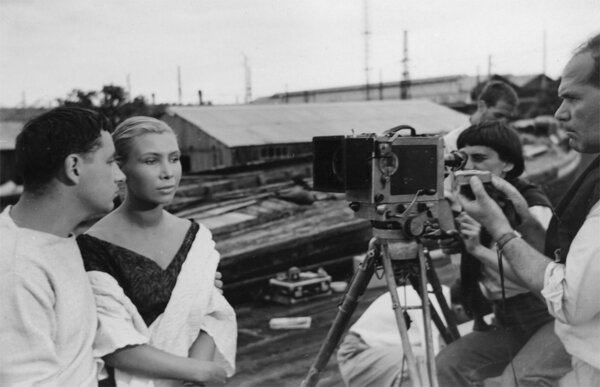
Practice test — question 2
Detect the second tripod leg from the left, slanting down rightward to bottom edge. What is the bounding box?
[381,241,423,387]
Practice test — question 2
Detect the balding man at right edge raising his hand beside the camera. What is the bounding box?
[461,34,600,386]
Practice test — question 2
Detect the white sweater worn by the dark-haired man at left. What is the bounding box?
[0,207,97,387]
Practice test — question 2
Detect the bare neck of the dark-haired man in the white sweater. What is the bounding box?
[10,192,85,237]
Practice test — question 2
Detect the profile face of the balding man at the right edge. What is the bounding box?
[554,52,600,153]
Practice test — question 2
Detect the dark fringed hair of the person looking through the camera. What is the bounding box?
[456,121,525,180]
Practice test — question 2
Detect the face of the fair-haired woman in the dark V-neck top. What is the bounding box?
[121,132,181,204]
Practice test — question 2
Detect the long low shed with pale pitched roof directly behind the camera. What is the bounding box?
[161,100,467,172]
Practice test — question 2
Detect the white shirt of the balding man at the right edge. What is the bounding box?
[542,202,600,370]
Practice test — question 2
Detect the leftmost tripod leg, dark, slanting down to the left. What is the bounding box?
[302,238,379,387]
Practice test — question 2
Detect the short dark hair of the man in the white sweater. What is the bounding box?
[15,107,112,191]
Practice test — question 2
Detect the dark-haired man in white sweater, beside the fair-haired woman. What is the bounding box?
[0,107,124,386]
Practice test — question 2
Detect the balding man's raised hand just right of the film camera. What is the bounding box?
[458,176,512,240]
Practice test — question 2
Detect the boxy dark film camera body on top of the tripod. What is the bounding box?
[313,125,466,236]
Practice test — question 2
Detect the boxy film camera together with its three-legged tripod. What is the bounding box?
[302,125,467,387]
